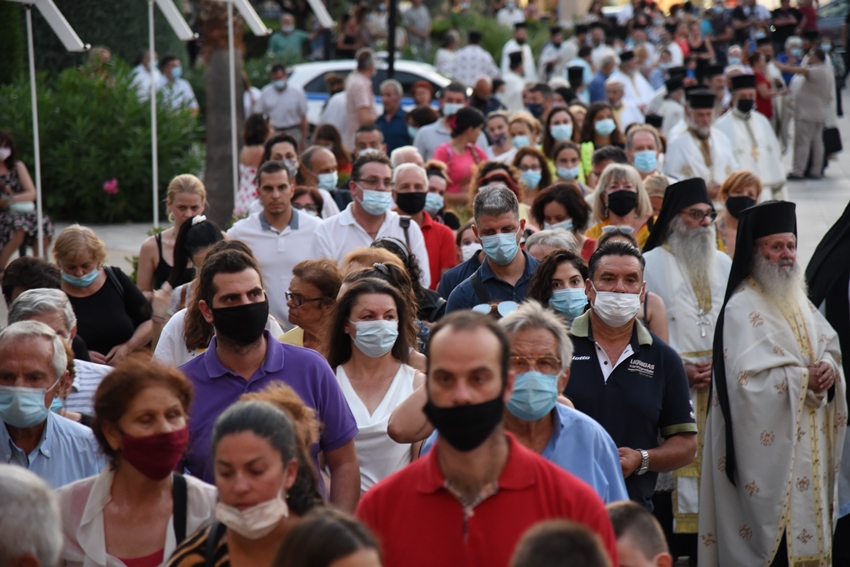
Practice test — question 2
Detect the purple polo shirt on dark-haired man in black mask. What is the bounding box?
[180,331,357,494]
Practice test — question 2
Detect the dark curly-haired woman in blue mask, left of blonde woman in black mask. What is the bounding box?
[531,183,596,261]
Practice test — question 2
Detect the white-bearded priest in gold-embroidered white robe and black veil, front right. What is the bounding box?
[698,201,847,567]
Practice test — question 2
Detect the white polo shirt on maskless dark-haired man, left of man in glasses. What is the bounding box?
[227,209,322,328]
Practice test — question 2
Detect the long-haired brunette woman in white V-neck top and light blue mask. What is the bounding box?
[327,278,425,492]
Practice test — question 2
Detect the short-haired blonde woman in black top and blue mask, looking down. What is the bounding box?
[53,224,152,365]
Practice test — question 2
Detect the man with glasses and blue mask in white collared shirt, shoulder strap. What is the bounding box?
[313,152,431,287]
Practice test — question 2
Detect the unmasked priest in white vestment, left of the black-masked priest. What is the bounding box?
[664,90,739,203]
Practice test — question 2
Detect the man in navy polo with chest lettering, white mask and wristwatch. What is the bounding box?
[564,241,697,510]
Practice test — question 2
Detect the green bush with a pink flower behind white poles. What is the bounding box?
[0,60,203,223]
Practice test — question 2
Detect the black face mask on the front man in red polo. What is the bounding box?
[422,393,505,453]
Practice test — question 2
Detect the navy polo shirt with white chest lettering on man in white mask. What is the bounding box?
[564,311,697,510]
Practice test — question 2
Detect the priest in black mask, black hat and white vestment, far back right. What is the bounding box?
[714,75,785,200]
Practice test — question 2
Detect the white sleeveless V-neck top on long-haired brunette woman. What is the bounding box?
[336,364,416,493]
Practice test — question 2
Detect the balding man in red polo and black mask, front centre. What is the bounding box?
[357,311,618,567]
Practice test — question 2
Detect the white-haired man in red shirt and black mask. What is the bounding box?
[393,163,457,289]
